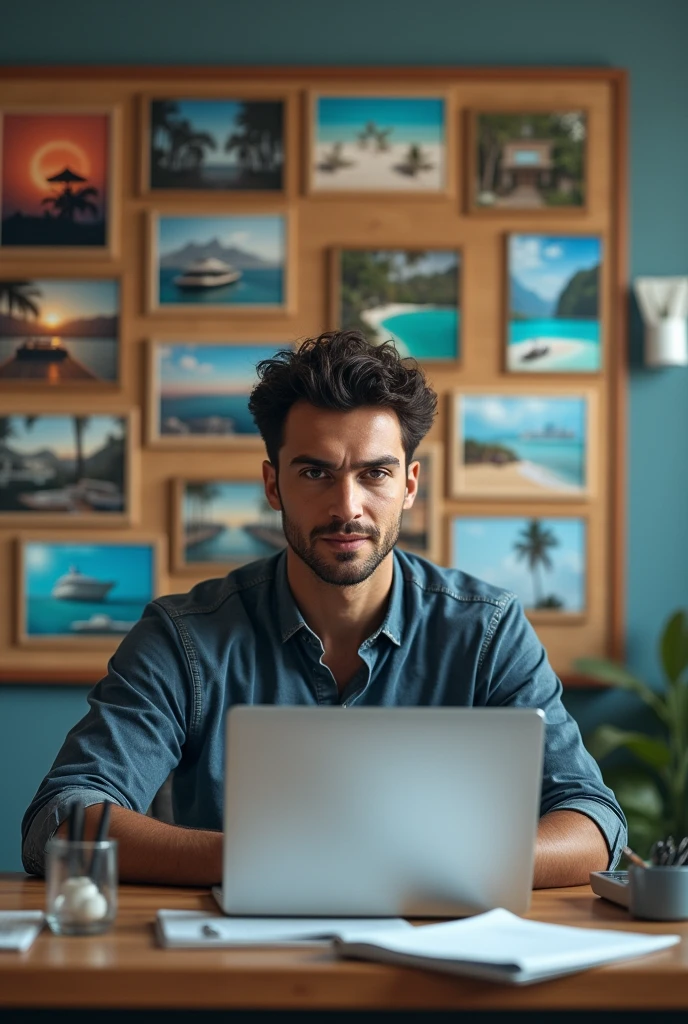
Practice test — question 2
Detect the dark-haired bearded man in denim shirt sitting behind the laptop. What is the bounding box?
[23,332,626,886]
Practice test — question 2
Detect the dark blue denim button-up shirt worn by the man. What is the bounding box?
[22,550,626,874]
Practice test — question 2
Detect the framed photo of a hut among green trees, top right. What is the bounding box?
[469,110,588,213]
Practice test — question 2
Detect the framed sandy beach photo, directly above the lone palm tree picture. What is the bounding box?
[450,389,597,501]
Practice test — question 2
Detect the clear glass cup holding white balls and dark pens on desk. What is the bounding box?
[45,839,117,935]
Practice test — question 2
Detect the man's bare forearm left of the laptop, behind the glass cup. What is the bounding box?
[57,804,222,886]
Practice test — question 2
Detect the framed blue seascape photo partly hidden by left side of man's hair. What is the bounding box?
[147,341,290,447]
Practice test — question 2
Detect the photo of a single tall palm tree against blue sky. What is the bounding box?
[452,516,586,614]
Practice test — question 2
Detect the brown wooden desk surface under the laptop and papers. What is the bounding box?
[0,874,688,1010]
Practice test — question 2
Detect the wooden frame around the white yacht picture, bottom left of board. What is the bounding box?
[15,530,166,651]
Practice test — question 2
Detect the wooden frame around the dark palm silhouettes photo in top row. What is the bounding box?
[138,84,298,199]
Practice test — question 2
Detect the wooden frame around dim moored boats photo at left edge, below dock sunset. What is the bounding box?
[0,409,140,529]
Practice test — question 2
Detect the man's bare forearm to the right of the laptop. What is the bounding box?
[532,811,609,889]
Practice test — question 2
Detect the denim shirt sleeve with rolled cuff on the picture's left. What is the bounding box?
[22,602,194,874]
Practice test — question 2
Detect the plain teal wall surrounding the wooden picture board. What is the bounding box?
[0,0,688,870]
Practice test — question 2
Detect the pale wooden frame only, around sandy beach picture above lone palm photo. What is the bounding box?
[448,381,599,504]
